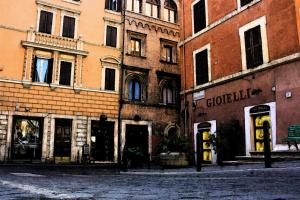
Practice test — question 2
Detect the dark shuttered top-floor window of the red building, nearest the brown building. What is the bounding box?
[192,0,207,33]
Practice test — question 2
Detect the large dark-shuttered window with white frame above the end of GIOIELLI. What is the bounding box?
[239,16,269,70]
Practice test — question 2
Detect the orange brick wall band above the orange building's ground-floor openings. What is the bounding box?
[0,82,119,118]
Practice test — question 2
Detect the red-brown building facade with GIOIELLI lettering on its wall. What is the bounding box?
[180,0,300,162]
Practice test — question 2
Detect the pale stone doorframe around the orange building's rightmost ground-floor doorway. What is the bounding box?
[86,117,118,163]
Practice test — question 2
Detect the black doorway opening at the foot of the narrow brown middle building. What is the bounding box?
[124,125,149,167]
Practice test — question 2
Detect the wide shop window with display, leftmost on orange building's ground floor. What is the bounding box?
[11,117,43,162]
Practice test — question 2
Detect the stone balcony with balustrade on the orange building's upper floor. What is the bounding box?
[22,28,88,56]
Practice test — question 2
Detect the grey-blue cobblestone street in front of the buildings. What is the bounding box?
[0,161,300,200]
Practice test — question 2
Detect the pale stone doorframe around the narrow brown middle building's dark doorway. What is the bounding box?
[120,120,152,161]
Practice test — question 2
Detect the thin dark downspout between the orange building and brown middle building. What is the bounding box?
[118,1,126,167]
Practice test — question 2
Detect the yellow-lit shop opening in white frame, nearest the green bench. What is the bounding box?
[250,105,272,152]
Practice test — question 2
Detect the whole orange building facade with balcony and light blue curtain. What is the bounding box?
[0,0,122,163]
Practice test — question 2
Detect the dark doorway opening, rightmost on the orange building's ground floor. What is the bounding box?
[91,121,115,162]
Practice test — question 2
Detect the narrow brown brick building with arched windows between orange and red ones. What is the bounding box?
[121,0,180,166]
